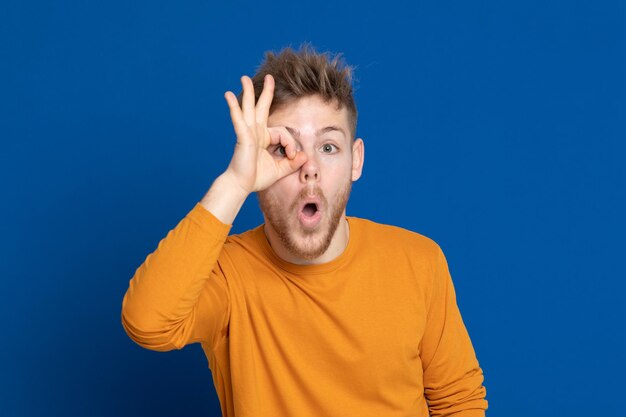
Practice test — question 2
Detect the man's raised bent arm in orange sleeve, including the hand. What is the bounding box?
[122,76,306,351]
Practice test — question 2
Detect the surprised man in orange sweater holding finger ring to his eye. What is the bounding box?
[122,48,487,417]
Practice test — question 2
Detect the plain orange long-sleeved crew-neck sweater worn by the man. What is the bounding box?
[122,204,487,417]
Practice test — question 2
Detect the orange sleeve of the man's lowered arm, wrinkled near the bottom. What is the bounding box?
[421,245,487,417]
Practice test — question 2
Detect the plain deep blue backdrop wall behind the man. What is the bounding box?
[0,0,626,416]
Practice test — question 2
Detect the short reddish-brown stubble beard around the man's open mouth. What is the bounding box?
[257,180,352,260]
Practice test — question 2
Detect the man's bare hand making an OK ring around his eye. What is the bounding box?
[224,75,306,193]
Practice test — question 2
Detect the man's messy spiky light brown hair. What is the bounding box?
[247,44,357,139]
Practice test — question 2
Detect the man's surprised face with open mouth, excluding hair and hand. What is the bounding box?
[258,96,363,261]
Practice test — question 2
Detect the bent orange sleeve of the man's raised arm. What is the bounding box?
[122,204,230,351]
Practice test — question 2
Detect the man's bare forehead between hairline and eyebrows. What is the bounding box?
[268,95,350,135]
